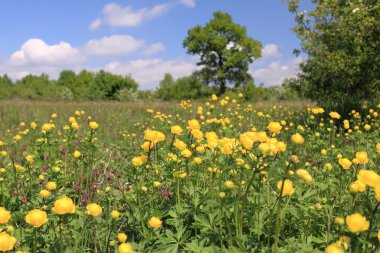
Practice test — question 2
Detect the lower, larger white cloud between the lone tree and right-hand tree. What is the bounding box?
[250,58,302,87]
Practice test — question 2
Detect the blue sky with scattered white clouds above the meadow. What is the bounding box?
[0,0,310,89]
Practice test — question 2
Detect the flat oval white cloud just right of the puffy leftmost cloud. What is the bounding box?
[84,35,145,56]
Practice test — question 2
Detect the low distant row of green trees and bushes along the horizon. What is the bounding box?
[0,70,297,101]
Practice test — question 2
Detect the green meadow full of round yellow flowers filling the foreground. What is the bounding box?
[0,95,380,253]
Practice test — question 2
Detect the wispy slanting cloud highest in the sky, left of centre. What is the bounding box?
[90,3,172,30]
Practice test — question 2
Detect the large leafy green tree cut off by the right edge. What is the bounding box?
[288,0,380,114]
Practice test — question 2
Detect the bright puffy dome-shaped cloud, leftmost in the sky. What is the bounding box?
[7,39,83,66]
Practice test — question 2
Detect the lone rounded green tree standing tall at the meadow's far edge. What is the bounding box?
[183,12,262,94]
